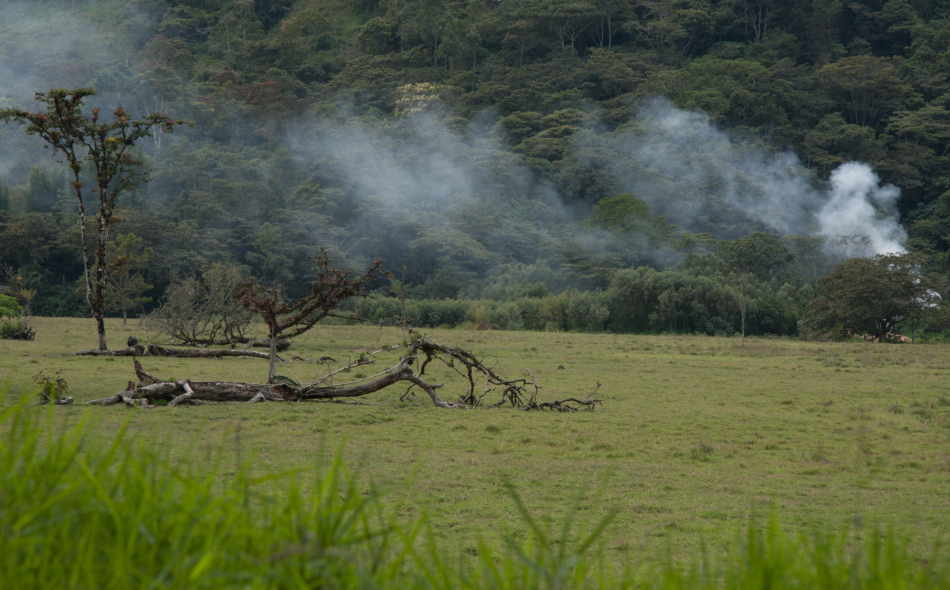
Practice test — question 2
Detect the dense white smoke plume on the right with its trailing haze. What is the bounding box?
[613,99,906,253]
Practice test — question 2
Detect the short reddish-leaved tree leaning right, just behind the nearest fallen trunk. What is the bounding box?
[241,250,383,383]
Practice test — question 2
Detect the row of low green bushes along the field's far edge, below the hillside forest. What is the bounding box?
[346,260,808,335]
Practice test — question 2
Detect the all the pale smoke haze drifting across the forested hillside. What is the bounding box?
[0,0,906,264]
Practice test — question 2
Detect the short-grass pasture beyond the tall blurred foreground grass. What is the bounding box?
[0,318,950,563]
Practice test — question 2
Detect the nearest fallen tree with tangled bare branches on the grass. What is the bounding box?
[87,333,602,412]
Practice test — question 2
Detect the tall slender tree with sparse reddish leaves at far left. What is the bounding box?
[0,88,185,350]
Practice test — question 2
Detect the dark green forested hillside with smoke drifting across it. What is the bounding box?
[0,0,950,333]
